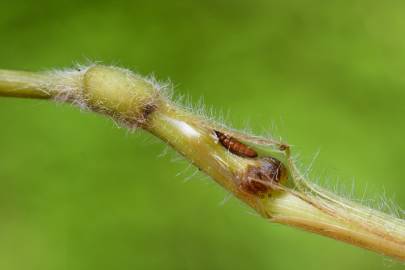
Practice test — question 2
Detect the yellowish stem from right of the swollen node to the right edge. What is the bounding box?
[147,100,405,260]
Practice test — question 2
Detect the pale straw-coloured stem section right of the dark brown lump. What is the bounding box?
[267,189,405,261]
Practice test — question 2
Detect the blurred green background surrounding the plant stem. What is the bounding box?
[0,0,405,270]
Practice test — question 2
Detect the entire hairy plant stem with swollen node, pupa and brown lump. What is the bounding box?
[0,66,405,261]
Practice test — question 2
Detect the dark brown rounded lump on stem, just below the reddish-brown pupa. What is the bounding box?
[240,157,288,197]
